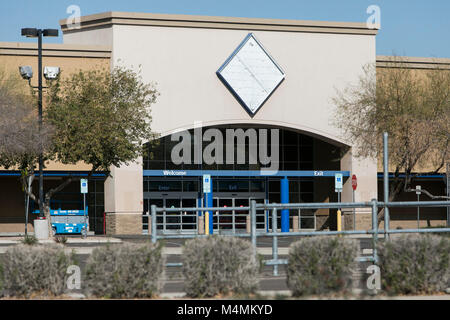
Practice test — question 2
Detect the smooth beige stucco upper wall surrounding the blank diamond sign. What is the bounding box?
[113,26,375,140]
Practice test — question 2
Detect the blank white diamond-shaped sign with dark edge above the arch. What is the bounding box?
[216,33,285,116]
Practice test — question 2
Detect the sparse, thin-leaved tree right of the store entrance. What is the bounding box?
[333,57,450,221]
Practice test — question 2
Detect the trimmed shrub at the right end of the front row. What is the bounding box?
[378,235,450,294]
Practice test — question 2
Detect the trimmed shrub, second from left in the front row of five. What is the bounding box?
[84,243,165,298]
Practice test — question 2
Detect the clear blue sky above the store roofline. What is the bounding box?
[0,0,450,58]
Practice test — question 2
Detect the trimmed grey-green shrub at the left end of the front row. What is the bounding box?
[3,245,75,297]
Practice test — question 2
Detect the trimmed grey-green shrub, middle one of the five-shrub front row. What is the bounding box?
[183,236,259,297]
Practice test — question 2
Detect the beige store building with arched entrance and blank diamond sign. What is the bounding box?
[0,12,445,234]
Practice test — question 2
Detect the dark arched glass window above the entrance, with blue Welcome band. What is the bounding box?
[143,122,349,176]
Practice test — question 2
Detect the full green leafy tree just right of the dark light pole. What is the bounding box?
[0,67,158,236]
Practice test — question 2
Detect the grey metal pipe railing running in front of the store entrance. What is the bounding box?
[144,199,450,276]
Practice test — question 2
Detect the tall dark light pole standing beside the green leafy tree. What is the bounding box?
[21,28,58,218]
